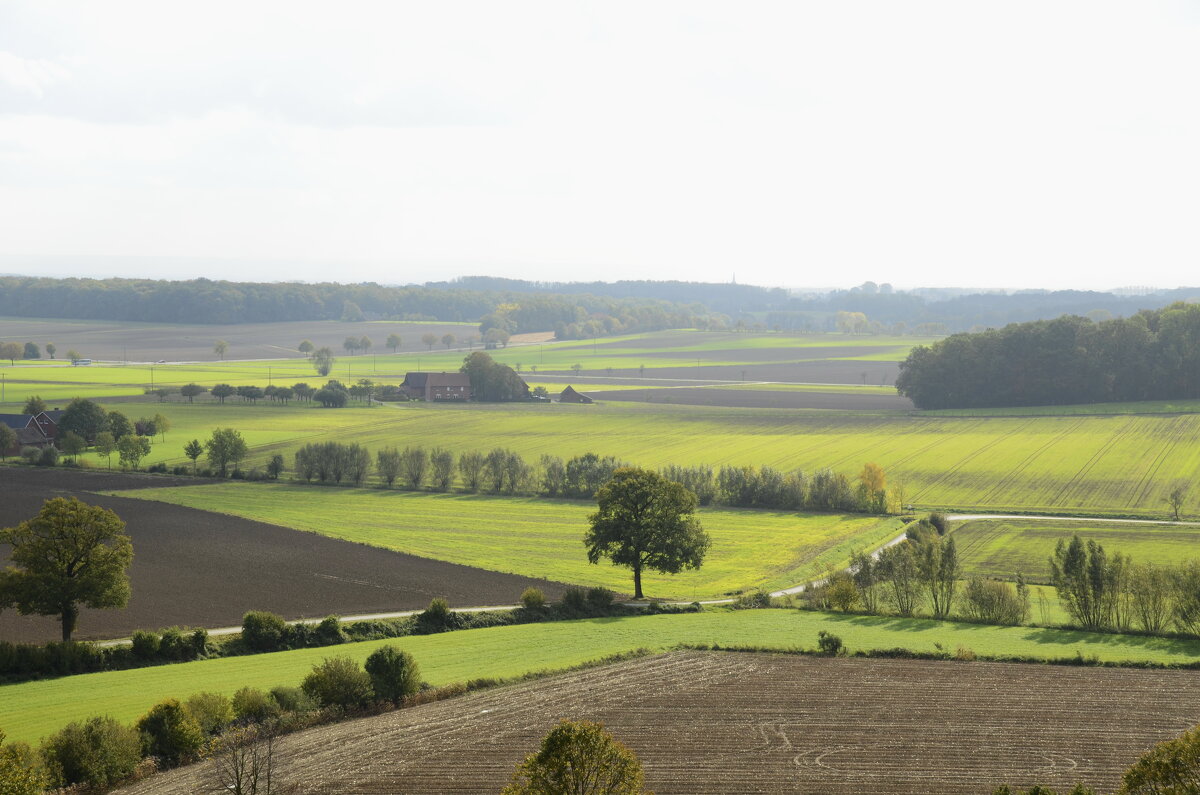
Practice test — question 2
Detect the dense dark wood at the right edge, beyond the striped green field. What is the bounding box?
[896,303,1200,408]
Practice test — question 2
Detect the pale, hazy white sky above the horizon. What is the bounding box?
[0,0,1200,288]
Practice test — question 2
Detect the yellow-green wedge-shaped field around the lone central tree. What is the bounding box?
[116,483,900,600]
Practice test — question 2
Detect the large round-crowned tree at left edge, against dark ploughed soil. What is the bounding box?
[0,497,133,642]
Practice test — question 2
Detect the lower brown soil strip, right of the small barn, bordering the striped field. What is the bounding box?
[595,385,916,411]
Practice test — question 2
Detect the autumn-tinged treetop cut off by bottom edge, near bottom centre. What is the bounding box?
[502,721,646,795]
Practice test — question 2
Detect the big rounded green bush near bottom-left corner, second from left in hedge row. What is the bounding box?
[42,717,142,789]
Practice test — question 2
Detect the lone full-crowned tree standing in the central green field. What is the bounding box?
[583,467,710,599]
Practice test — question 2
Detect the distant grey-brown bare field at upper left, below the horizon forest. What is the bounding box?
[0,317,479,361]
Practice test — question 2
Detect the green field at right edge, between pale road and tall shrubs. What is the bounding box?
[953,519,1200,582]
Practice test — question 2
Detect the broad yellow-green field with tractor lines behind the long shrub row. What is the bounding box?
[51,400,1200,519]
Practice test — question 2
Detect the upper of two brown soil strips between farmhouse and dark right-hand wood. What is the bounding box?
[538,360,900,387]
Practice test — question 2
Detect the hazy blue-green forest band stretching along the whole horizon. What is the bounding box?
[0,276,1200,339]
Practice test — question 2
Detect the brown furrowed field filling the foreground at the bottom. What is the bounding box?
[121,652,1200,795]
